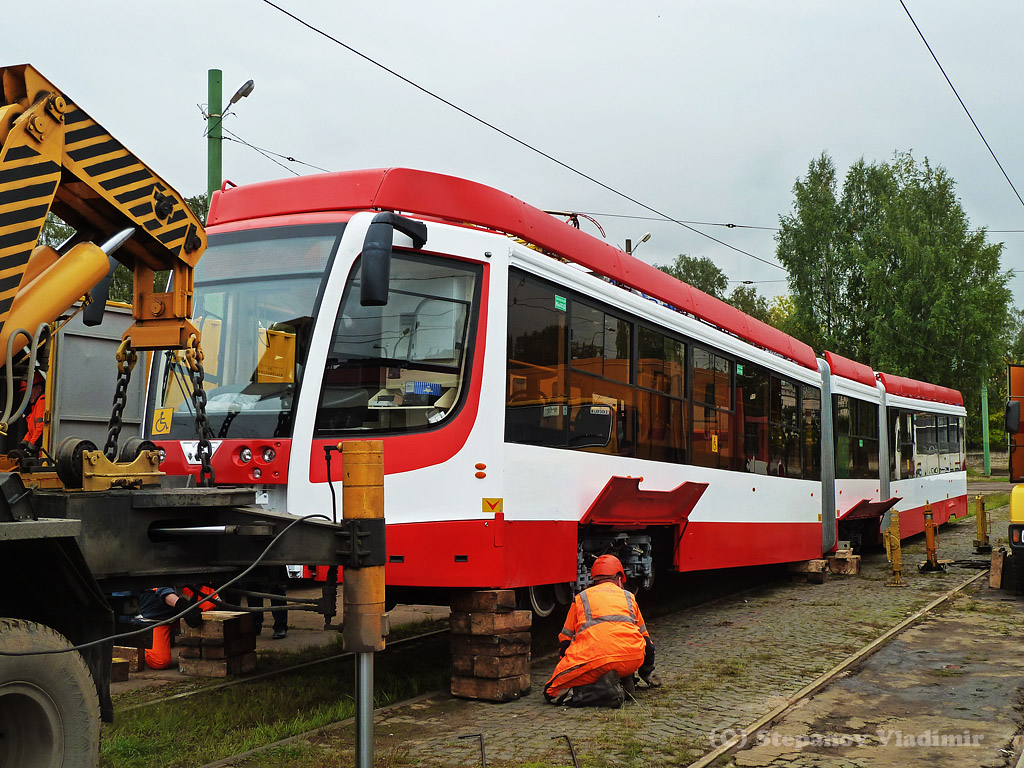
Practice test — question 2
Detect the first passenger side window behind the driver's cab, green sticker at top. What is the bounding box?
[505,272,568,446]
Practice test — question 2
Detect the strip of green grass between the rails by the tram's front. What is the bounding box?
[100,639,451,768]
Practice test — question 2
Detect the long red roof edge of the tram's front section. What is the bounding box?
[209,168,817,370]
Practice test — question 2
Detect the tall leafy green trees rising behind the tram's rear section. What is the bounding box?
[777,153,1011,442]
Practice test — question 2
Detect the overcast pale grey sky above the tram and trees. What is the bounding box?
[8,0,1024,305]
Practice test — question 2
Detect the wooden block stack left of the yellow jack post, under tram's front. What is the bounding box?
[178,610,256,677]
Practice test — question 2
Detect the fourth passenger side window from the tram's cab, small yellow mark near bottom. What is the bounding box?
[690,346,739,469]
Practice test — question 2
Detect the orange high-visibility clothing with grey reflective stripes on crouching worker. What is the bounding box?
[545,582,650,695]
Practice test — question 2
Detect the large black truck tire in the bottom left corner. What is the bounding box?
[0,618,99,768]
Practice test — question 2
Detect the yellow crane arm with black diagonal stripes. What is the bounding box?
[0,65,206,354]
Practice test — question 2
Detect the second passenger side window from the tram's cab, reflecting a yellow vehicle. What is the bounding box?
[568,300,637,456]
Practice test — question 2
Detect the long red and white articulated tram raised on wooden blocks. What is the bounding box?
[147,169,967,612]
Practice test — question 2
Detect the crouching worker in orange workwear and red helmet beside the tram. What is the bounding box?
[544,555,660,707]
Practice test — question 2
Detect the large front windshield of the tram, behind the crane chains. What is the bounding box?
[151,224,344,439]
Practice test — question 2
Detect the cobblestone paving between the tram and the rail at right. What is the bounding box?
[323,489,1007,768]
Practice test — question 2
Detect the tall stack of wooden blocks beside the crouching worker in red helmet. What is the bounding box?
[451,590,532,701]
